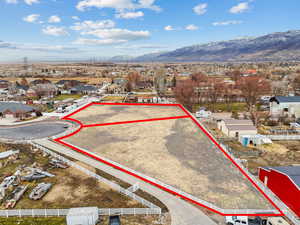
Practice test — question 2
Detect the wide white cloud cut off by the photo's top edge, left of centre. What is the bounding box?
[76,0,160,11]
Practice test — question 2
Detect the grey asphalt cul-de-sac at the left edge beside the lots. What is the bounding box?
[0,122,66,140]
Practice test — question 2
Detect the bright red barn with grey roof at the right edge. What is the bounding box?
[259,166,300,217]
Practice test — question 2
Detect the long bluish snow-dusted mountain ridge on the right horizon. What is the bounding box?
[132,30,300,62]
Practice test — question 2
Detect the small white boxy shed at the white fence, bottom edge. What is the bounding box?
[67,207,99,225]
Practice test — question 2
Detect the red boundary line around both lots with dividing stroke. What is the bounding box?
[54,103,284,216]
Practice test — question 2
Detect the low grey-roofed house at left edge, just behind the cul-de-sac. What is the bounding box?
[0,102,36,119]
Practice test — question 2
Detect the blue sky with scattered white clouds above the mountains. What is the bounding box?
[0,0,300,62]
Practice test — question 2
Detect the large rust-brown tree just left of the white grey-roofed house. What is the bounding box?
[236,76,271,111]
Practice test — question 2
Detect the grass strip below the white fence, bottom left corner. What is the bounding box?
[0,217,66,225]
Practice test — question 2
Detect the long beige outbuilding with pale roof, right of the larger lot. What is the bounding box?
[217,119,257,138]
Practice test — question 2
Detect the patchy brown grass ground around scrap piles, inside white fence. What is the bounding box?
[0,143,144,209]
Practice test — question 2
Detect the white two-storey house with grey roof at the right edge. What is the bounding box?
[270,96,300,118]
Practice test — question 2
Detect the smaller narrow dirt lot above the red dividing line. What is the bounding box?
[71,105,186,124]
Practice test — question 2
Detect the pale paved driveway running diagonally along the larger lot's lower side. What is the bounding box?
[35,139,216,225]
